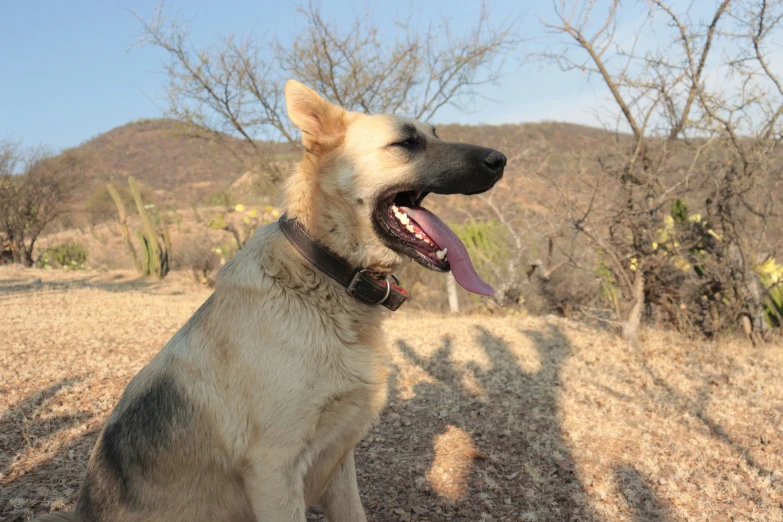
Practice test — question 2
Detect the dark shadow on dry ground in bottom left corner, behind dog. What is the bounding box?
[0,378,98,522]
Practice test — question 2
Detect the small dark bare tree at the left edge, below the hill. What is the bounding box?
[0,142,80,266]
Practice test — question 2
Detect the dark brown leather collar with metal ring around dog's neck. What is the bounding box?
[279,214,408,311]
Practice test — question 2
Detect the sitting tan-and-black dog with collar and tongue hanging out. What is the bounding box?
[33,80,506,522]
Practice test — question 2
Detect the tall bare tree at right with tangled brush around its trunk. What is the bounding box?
[536,0,783,338]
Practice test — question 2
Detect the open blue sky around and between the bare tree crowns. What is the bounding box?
[0,0,711,149]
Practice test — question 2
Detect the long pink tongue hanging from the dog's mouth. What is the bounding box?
[400,207,495,295]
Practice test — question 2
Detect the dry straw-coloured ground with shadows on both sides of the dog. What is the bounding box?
[0,267,783,522]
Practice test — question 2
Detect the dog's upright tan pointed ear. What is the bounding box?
[285,80,346,152]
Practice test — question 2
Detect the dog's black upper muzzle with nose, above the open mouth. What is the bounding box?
[422,142,506,195]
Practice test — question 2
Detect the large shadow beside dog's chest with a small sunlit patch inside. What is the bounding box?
[340,326,595,522]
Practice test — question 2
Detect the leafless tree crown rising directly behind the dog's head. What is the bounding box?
[136,1,519,177]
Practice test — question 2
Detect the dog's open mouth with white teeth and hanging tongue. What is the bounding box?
[375,191,495,295]
